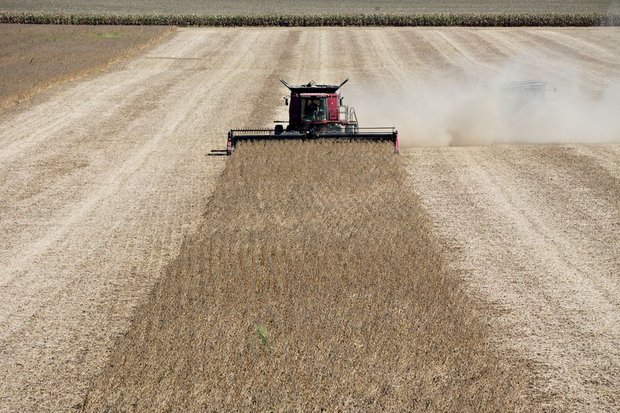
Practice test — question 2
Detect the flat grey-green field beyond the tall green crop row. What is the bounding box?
[0,0,619,15]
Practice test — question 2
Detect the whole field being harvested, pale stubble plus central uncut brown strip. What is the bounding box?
[0,28,620,412]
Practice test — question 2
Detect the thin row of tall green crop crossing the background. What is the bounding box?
[0,13,620,27]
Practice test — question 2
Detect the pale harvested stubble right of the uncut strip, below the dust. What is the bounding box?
[407,146,620,412]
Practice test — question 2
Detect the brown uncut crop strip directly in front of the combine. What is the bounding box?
[85,142,531,412]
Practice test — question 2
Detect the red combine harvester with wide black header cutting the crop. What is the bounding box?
[226,79,399,155]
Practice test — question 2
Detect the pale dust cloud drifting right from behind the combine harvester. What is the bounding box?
[347,63,620,146]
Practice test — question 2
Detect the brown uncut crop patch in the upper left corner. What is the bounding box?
[0,24,171,108]
